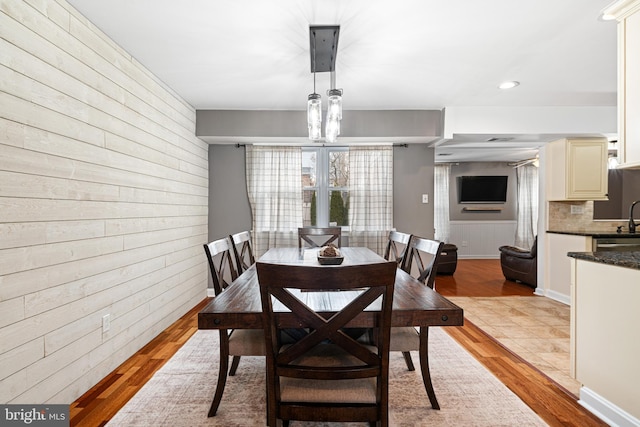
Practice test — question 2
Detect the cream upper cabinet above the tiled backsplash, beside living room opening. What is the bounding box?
[547,138,608,200]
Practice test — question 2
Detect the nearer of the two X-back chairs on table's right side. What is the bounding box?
[390,235,443,409]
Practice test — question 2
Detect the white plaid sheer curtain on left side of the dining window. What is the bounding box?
[246,145,302,257]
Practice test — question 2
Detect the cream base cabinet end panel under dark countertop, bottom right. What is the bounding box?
[571,258,640,426]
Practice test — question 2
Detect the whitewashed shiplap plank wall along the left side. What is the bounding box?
[0,0,208,404]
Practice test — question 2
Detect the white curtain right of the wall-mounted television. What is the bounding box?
[515,165,538,248]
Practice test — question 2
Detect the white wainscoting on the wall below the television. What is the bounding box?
[449,221,516,259]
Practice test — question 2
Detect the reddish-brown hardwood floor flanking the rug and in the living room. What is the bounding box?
[70,260,607,427]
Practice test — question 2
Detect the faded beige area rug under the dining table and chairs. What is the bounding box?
[108,327,547,427]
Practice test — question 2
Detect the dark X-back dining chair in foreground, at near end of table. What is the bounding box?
[256,261,397,426]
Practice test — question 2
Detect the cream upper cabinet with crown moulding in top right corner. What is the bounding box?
[604,0,640,169]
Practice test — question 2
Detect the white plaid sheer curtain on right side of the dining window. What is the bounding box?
[349,146,393,255]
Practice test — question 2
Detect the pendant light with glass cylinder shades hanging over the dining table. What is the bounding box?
[307,25,342,142]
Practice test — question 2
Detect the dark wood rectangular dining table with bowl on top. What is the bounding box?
[198,247,463,329]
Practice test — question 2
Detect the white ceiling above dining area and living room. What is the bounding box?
[68,0,616,161]
